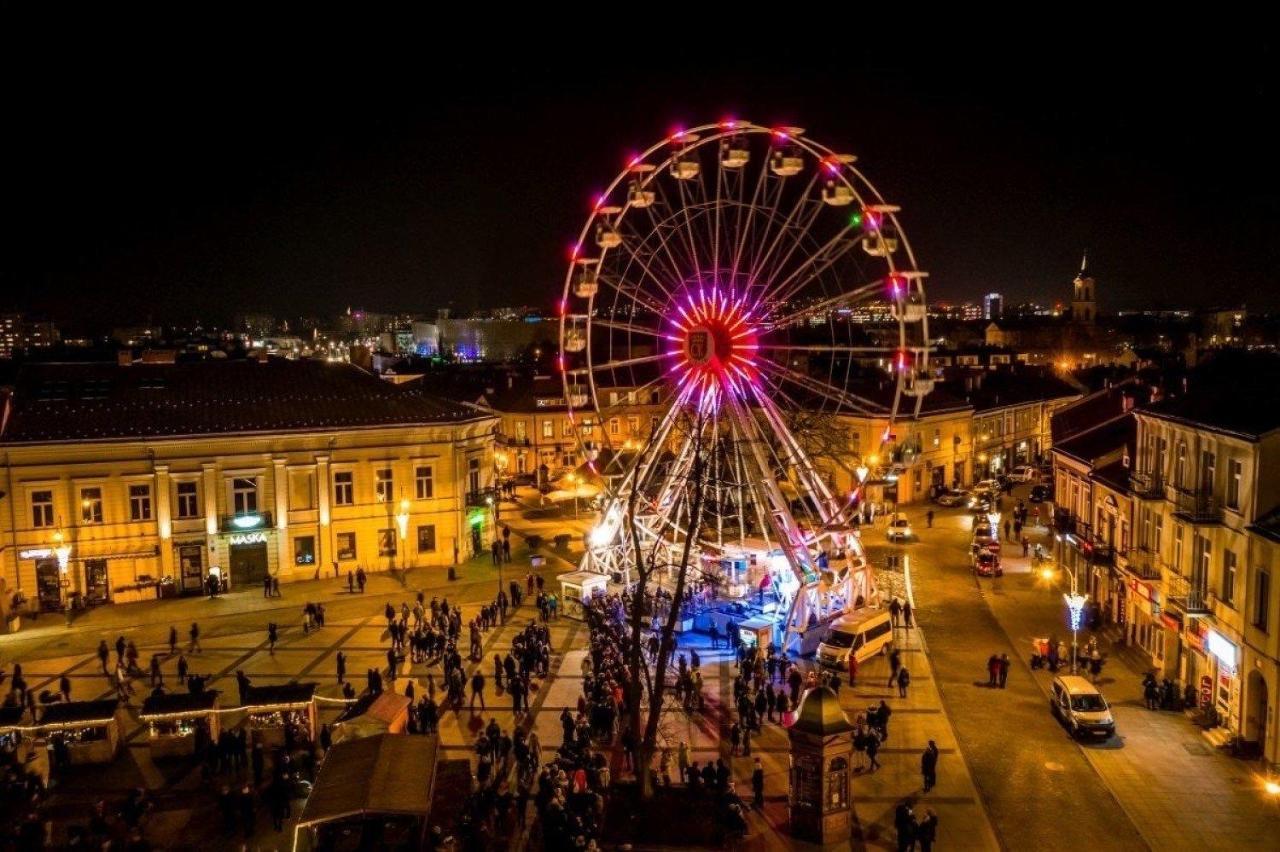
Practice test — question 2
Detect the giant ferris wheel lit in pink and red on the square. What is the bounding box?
[559,120,933,649]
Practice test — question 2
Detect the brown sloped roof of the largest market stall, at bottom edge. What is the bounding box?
[298,734,439,825]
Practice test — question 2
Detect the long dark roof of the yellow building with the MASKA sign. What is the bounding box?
[0,358,485,444]
